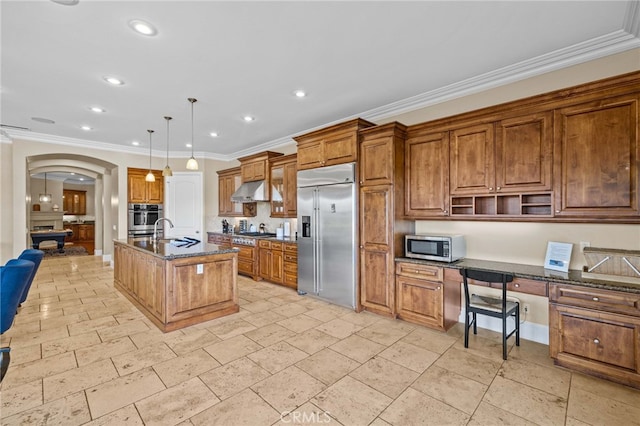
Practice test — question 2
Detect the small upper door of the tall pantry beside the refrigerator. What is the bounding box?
[359,136,394,185]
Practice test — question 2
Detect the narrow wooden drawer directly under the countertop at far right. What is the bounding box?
[549,283,640,317]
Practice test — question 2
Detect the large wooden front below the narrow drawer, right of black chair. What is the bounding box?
[549,305,640,372]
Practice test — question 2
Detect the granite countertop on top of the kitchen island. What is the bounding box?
[114,237,239,260]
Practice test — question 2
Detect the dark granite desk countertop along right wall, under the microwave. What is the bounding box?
[396,257,640,294]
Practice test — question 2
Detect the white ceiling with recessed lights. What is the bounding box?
[0,0,640,160]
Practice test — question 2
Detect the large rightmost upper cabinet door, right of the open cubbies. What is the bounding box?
[554,95,640,216]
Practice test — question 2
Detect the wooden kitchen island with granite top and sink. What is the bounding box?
[114,237,240,332]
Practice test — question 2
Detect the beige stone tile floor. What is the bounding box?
[0,256,640,426]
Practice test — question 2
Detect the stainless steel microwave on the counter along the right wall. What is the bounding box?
[404,234,467,262]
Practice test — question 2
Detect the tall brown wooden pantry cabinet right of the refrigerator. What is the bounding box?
[359,123,413,316]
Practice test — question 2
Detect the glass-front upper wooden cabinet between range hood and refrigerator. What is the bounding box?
[269,154,298,218]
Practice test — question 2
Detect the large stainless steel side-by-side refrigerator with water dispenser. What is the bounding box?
[298,163,357,308]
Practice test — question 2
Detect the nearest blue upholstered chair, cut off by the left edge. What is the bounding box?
[0,259,35,382]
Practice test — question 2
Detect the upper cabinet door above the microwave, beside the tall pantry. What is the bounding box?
[404,133,449,218]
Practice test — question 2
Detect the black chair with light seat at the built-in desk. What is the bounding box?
[460,269,520,360]
